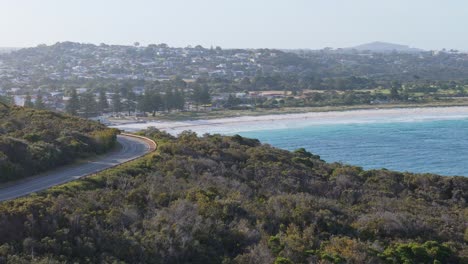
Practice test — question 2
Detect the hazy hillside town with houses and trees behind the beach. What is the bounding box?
[0,42,468,120]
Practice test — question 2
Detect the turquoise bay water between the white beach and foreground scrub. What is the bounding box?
[239,119,468,176]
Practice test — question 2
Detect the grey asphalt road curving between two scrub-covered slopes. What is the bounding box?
[0,135,155,201]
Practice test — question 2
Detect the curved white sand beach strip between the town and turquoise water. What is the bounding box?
[112,106,468,135]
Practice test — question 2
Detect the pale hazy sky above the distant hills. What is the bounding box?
[0,0,468,50]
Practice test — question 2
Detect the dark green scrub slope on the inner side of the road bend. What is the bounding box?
[0,105,117,182]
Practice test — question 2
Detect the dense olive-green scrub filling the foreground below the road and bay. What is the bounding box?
[0,130,468,263]
